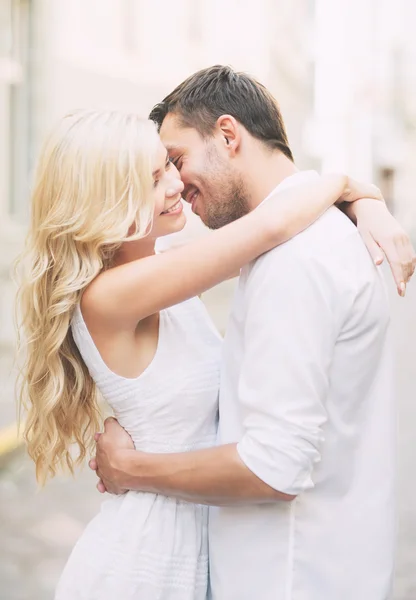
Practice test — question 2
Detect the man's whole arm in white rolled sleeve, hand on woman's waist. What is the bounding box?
[97,249,334,505]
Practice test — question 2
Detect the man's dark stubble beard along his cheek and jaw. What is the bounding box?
[202,149,250,229]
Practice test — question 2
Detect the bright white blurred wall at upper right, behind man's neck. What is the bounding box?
[307,0,416,234]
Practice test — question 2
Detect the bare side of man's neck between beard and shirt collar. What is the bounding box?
[244,150,299,210]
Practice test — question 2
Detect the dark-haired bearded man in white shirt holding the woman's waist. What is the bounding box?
[92,66,413,600]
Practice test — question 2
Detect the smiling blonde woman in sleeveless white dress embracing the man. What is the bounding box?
[15,112,412,600]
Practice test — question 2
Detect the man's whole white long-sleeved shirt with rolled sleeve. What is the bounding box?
[210,172,396,600]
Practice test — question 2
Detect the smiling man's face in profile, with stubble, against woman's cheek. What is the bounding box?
[160,114,249,229]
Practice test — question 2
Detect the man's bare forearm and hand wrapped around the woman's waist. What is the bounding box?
[97,438,294,506]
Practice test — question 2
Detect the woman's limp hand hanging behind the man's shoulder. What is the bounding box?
[347,199,416,296]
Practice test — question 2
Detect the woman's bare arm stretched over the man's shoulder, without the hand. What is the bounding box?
[83,175,359,328]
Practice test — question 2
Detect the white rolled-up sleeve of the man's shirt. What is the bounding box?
[237,247,342,495]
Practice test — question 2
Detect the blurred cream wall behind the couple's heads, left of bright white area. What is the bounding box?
[0,0,313,348]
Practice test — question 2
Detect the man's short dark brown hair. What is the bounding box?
[149,65,293,161]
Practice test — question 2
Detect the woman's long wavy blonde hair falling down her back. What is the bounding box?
[15,111,159,485]
